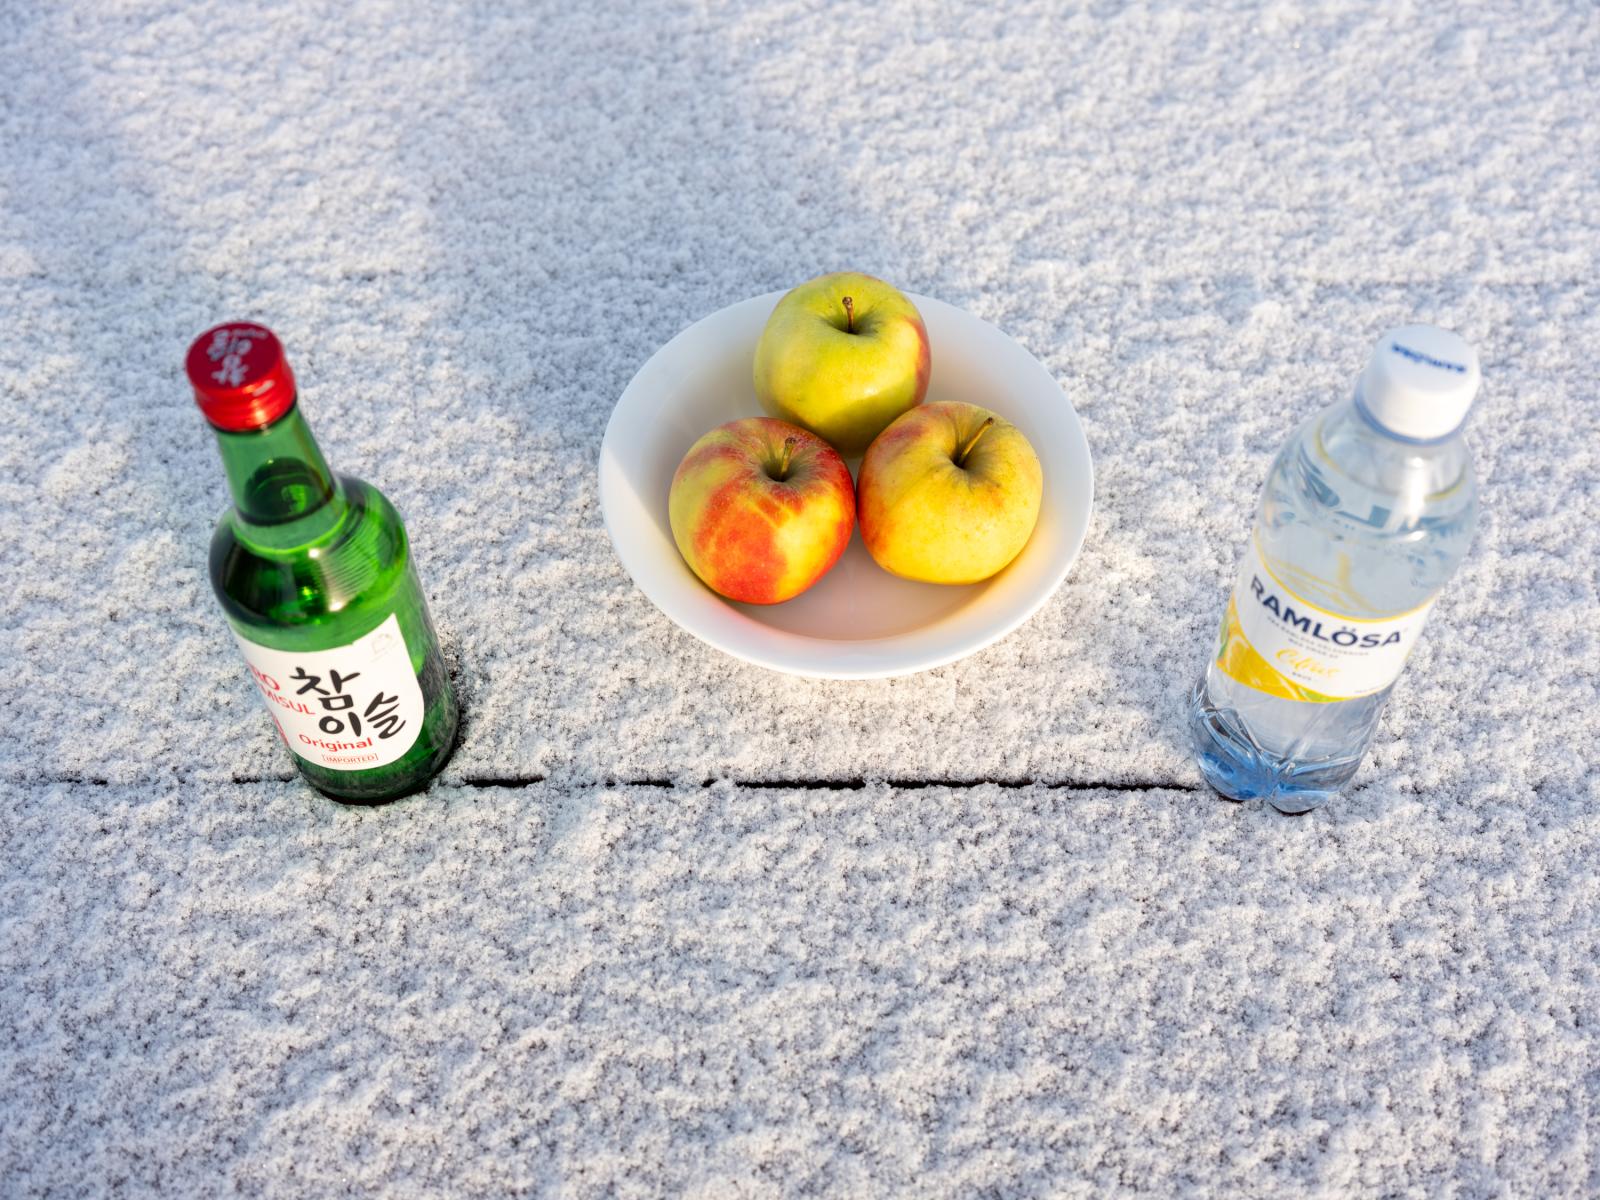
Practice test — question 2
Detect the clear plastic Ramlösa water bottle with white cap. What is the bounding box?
[1189,325,1478,813]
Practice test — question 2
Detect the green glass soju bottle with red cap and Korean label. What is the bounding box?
[187,323,456,803]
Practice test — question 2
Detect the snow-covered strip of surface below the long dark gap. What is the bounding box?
[0,784,1600,1197]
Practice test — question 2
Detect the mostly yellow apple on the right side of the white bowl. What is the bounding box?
[856,402,1045,584]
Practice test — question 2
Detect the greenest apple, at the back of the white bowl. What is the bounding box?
[755,270,930,458]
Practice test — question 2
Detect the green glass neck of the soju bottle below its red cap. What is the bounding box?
[213,403,349,550]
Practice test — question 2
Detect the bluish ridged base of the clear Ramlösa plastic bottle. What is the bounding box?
[1189,675,1363,816]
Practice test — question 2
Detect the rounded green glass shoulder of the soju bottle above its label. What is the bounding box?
[210,475,414,637]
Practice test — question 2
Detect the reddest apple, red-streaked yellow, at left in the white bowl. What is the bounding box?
[667,416,856,605]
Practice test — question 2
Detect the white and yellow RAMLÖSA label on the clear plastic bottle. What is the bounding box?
[1216,538,1434,702]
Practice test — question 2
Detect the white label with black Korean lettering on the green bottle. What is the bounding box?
[234,613,422,771]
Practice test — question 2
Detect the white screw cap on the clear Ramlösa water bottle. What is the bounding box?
[1358,325,1478,442]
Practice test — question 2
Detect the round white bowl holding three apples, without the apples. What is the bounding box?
[600,291,1094,678]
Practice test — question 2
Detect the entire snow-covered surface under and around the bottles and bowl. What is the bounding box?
[0,0,1600,1197]
